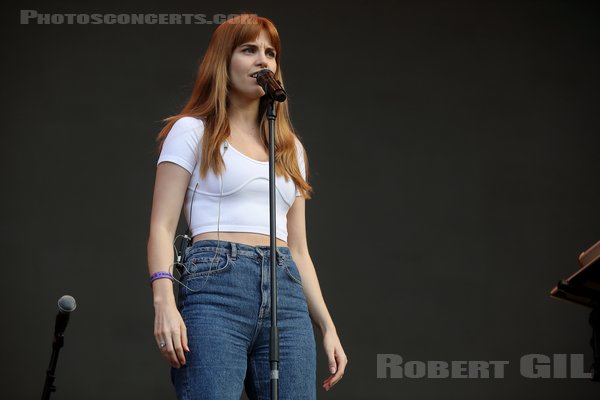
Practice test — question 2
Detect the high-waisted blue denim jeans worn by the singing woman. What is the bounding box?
[171,240,316,400]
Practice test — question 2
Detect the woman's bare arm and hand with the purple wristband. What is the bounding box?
[148,162,190,367]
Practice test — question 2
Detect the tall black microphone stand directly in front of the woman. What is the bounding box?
[267,99,279,400]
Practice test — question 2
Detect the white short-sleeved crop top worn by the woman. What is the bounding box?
[156,117,306,242]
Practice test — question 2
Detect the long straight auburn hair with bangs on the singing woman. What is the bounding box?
[156,14,313,199]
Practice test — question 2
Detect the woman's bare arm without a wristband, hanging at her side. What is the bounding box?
[287,196,348,390]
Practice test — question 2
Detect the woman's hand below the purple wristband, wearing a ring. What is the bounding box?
[154,301,190,368]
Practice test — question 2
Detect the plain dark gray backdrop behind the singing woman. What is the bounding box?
[0,0,600,399]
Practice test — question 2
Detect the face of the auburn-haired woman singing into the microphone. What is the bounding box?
[229,31,277,99]
